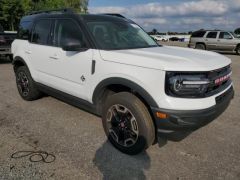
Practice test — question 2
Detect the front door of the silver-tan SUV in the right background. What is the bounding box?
[217,32,236,51]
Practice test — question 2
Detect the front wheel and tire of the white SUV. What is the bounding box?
[102,92,155,155]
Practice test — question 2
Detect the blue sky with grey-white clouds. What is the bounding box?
[89,0,240,32]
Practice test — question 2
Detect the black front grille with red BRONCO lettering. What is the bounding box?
[206,66,232,96]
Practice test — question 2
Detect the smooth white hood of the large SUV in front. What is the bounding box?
[100,46,231,71]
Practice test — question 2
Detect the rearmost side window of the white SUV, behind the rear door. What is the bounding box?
[17,21,32,40]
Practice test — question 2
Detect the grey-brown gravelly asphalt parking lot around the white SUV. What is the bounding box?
[0,43,240,180]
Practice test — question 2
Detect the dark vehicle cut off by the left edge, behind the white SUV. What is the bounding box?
[0,26,17,61]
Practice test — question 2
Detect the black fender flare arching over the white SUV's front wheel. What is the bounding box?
[92,77,158,107]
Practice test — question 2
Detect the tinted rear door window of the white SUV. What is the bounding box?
[32,19,52,45]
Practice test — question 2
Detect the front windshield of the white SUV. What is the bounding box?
[87,21,158,50]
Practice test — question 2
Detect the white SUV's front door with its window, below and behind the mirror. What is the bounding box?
[33,18,93,99]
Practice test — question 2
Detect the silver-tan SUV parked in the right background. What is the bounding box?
[188,30,240,54]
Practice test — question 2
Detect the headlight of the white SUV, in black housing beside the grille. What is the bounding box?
[165,72,210,98]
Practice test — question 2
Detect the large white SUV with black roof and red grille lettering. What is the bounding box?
[12,10,233,154]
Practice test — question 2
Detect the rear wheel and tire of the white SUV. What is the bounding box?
[15,66,42,101]
